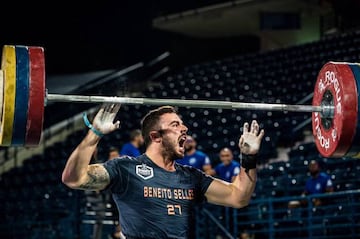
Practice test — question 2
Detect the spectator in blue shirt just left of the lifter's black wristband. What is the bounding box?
[210,147,240,183]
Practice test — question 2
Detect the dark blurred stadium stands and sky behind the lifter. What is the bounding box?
[0,0,360,239]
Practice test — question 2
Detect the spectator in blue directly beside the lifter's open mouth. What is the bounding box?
[176,135,212,174]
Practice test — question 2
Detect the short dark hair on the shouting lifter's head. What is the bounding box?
[141,106,177,146]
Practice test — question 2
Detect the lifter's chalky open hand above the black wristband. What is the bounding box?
[239,120,265,155]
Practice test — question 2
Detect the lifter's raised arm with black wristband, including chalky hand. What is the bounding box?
[205,120,264,208]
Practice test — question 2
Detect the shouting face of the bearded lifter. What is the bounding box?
[160,113,188,160]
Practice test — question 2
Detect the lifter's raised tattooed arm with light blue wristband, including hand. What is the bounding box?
[62,104,120,190]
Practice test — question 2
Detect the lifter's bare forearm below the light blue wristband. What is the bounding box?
[62,131,100,188]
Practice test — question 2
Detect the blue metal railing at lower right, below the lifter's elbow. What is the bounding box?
[196,190,360,239]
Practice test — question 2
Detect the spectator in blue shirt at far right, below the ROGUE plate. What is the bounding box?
[303,160,334,206]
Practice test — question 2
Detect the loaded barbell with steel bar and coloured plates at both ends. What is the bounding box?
[0,45,360,157]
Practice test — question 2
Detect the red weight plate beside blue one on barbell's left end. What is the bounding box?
[25,46,45,146]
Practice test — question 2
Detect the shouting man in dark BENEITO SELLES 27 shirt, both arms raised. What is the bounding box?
[62,104,264,239]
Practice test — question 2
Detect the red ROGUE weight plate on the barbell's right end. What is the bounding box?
[312,62,358,158]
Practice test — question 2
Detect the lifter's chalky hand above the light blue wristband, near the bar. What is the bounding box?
[93,103,121,134]
